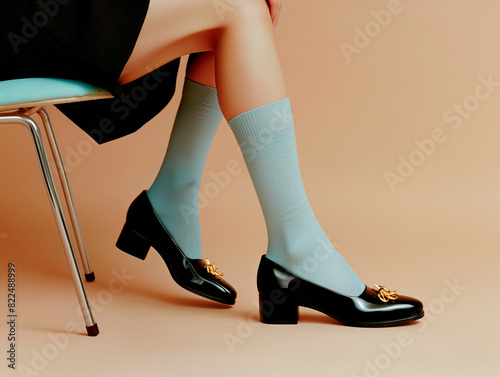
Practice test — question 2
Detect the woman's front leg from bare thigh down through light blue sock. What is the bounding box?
[122,0,364,296]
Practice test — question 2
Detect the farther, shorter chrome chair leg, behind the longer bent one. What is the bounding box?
[37,107,95,281]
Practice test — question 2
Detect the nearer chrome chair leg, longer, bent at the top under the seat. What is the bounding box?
[0,114,99,336]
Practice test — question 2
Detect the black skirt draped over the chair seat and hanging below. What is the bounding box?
[0,0,179,144]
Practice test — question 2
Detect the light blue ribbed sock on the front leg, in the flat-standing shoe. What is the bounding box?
[229,99,365,296]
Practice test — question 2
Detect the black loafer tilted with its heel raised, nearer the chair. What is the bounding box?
[116,191,236,305]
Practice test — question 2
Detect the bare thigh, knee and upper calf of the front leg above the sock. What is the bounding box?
[120,0,287,119]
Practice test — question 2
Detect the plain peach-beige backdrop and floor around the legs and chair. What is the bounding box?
[0,0,500,377]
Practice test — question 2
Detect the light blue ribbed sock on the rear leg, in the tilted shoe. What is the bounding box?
[147,78,222,259]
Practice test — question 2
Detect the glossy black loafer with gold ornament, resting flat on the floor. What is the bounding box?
[257,255,424,327]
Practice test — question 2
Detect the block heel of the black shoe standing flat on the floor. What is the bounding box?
[259,290,299,325]
